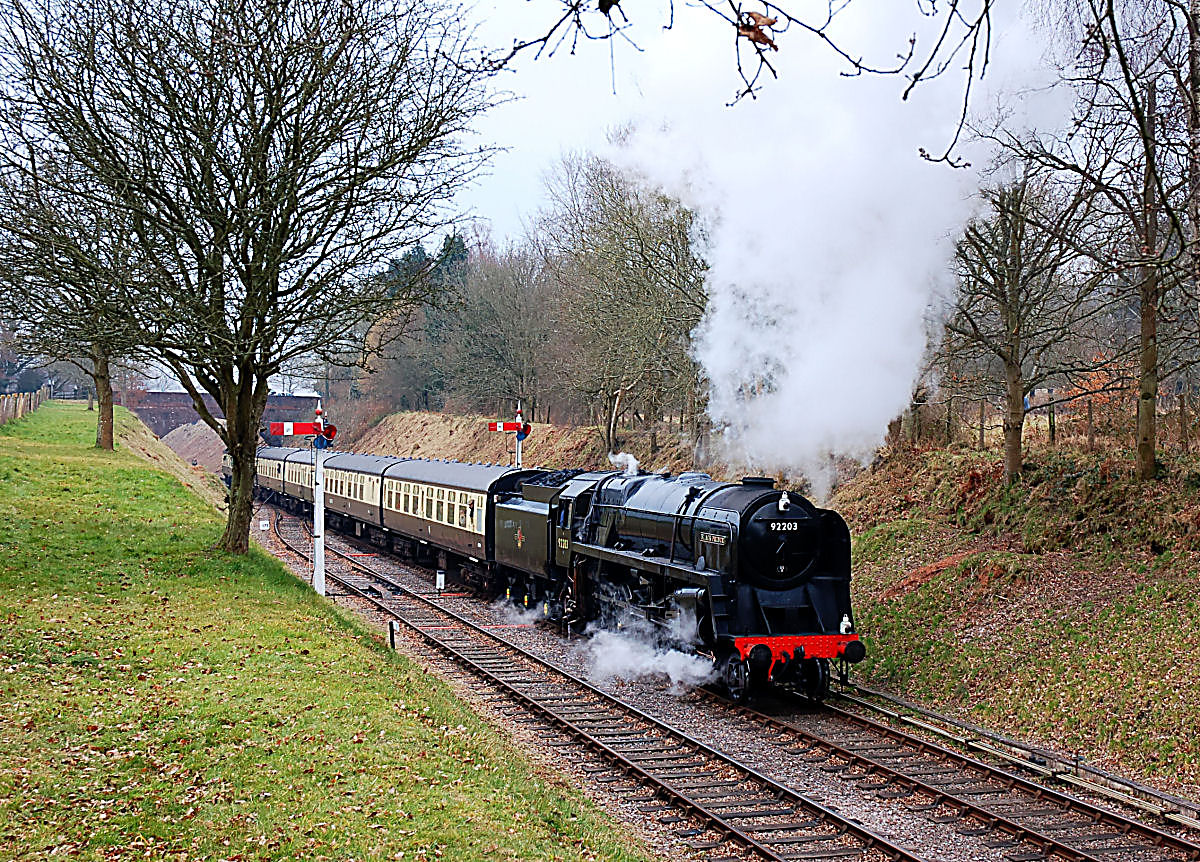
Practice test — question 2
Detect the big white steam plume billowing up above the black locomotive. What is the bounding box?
[600,2,1060,483]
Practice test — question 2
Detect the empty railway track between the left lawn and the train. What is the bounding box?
[275,513,923,862]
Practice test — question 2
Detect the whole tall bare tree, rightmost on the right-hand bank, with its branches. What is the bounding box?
[995,0,1188,479]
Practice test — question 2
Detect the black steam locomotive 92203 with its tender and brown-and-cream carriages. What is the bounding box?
[246,449,865,699]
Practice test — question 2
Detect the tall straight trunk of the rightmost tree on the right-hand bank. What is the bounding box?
[1136,78,1158,480]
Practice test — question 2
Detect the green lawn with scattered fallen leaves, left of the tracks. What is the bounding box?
[0,403,643,860]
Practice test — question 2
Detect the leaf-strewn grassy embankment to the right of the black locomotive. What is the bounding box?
[834,449,1200,797]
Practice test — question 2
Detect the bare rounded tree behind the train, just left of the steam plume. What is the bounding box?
[539,157,707,447]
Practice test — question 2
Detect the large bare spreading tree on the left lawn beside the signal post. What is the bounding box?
[0,0,488,552]
